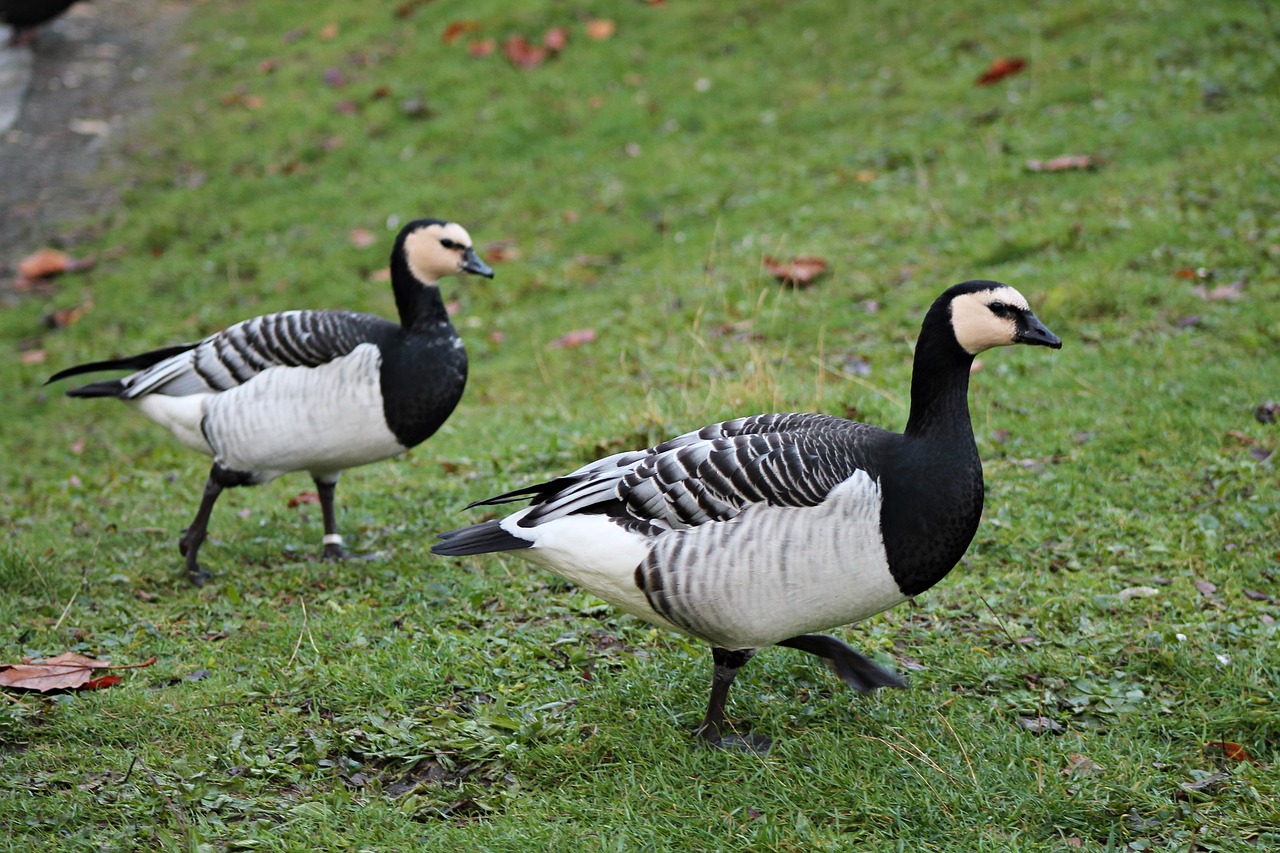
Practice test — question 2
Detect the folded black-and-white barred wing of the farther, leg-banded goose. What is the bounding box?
[50,311,396,400]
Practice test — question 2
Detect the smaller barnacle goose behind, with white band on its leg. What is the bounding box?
[46,219,493,585]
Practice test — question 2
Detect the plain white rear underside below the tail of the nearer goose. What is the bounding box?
[499,508,680,630]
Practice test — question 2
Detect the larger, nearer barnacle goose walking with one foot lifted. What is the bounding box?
[431,282,1062,749]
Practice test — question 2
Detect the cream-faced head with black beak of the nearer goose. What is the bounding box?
[938,282,1062,356]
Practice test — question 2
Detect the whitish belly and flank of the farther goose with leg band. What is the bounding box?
[204,345,406,482]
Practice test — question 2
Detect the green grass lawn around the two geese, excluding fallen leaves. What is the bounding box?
[0,0,1280,852]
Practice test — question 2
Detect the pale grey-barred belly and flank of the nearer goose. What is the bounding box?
[643,471,908,648]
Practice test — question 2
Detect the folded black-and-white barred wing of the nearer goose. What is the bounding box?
[474,414,890,533]
